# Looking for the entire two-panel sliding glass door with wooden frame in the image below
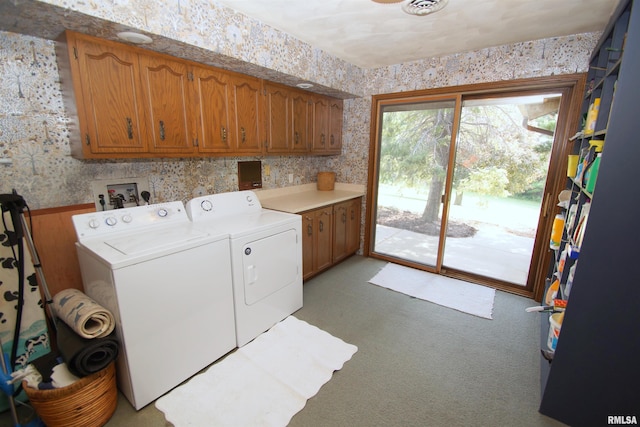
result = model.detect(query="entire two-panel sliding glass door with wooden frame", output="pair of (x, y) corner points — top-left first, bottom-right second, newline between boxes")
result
(369, 85), (566, 296)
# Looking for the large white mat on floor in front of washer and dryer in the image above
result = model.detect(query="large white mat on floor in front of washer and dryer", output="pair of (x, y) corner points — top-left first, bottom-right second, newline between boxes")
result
(156, 316), (358, 427)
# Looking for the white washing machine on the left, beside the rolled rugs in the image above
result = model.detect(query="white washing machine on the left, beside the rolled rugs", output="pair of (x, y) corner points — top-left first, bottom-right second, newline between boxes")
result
(72, 202), (236, 410)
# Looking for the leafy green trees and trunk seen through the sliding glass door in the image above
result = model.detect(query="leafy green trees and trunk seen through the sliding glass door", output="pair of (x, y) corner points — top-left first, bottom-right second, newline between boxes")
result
(379, 102), (556, 221)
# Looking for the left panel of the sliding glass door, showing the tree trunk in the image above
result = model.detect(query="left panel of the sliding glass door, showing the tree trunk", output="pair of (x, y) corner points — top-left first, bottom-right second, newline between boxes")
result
(374, 98), (457, 269)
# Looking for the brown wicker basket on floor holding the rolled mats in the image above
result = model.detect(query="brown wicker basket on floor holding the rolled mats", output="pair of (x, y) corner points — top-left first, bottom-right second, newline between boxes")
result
(22, 362), (118, 427)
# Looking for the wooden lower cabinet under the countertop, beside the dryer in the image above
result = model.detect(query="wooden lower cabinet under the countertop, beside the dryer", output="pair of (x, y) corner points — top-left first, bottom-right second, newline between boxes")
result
(301, 198), (362, 280)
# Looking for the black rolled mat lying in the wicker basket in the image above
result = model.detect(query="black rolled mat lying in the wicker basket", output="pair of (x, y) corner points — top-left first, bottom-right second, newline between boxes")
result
(56, 322), (118, 377)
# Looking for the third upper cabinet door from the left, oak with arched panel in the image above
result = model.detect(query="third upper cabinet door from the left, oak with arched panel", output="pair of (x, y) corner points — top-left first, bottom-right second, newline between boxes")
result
(193, 67), (237, 153)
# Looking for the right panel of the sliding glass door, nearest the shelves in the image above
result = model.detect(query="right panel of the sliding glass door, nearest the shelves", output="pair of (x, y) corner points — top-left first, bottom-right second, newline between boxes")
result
(442, 93), (561, 286)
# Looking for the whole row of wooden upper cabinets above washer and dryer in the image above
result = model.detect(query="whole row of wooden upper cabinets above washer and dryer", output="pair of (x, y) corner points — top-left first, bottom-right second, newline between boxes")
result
(56, 31), (342, 159)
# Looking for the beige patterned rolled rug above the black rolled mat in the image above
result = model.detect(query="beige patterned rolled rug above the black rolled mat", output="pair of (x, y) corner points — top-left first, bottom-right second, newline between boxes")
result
(52, 289), (116, 338)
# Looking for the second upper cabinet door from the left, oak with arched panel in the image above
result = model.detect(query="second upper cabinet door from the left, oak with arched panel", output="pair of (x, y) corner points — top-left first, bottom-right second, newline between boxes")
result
(140, 55), (195, 153)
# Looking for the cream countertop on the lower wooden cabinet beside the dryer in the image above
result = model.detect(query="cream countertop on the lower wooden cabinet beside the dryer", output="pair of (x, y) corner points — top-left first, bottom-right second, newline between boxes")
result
(254, 182), (364, 213)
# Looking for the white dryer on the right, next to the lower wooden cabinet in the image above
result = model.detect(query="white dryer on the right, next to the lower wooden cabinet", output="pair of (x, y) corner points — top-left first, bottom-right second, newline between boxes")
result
(186, 191), (302, 347)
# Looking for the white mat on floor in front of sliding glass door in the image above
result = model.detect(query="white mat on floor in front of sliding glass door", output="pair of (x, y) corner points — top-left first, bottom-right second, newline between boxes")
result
(369, 263), (496, 319)
